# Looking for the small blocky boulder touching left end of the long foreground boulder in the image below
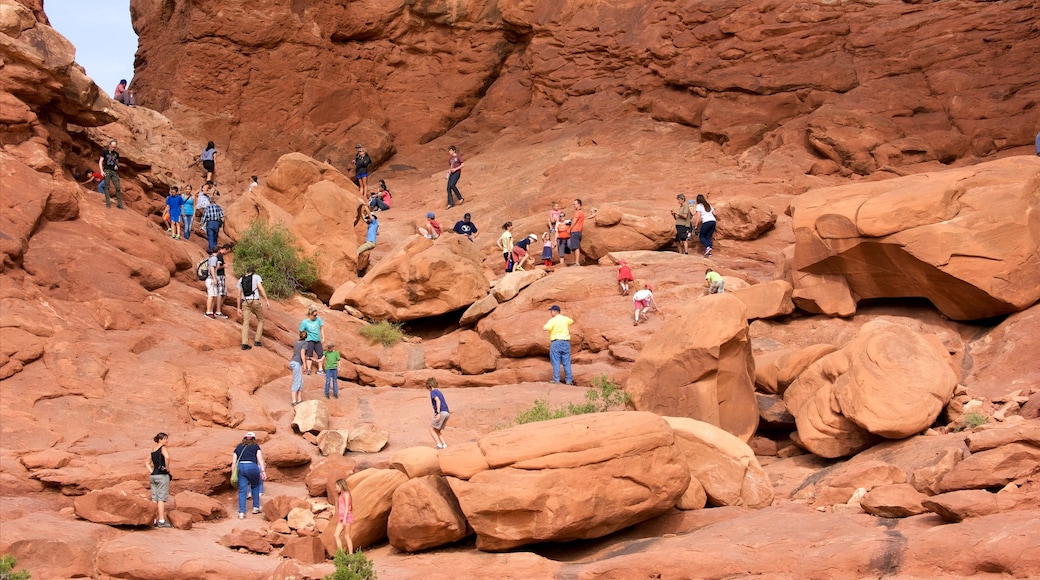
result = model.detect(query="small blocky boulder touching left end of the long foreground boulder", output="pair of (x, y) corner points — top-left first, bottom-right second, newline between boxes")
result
(387, 475), (472, 552)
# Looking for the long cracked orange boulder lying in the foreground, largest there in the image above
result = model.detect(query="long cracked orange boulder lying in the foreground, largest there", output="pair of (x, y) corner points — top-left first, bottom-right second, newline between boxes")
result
(441, 412), (690, 551)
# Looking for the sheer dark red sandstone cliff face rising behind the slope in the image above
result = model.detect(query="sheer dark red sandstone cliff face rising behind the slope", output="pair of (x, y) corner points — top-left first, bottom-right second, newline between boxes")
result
(131, 0), (1040, 175)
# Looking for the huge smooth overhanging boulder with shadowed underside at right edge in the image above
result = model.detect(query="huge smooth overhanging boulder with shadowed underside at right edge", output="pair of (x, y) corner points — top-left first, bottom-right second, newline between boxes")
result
(788, 157), (1040, 320)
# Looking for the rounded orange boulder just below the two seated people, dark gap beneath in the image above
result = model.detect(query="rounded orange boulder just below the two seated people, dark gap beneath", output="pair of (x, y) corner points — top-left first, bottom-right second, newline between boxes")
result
(344, 235), (488, 321)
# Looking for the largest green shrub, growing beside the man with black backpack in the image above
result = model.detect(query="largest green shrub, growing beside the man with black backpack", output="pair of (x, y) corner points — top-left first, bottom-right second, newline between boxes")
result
(233, 219), (318, 298)
